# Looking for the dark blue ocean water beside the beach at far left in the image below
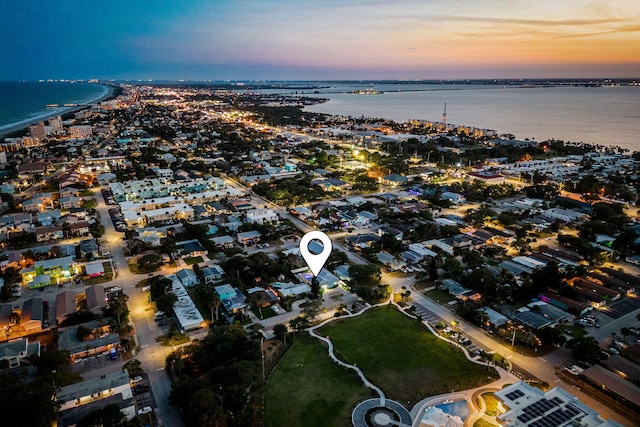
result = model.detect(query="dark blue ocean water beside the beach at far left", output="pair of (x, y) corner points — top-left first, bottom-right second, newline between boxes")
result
(0, 82), (109, 132)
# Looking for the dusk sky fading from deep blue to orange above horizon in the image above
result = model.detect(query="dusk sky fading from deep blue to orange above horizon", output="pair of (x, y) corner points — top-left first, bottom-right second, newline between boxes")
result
(0, 0), (640, 80)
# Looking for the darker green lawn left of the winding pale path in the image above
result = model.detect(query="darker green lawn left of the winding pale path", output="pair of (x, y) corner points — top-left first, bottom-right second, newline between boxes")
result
(265, 336), (372, 427)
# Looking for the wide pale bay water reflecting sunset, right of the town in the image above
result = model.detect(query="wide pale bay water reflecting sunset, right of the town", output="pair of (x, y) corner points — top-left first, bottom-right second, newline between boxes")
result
(305, 83), (640, 152)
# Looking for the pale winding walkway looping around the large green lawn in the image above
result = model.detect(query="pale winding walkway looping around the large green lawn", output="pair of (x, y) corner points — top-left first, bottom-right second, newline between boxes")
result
(307, 294), (519, 427)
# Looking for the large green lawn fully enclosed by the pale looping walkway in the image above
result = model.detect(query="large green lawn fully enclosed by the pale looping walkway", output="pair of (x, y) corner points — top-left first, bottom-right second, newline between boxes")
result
(318, 306), (497, 404)
